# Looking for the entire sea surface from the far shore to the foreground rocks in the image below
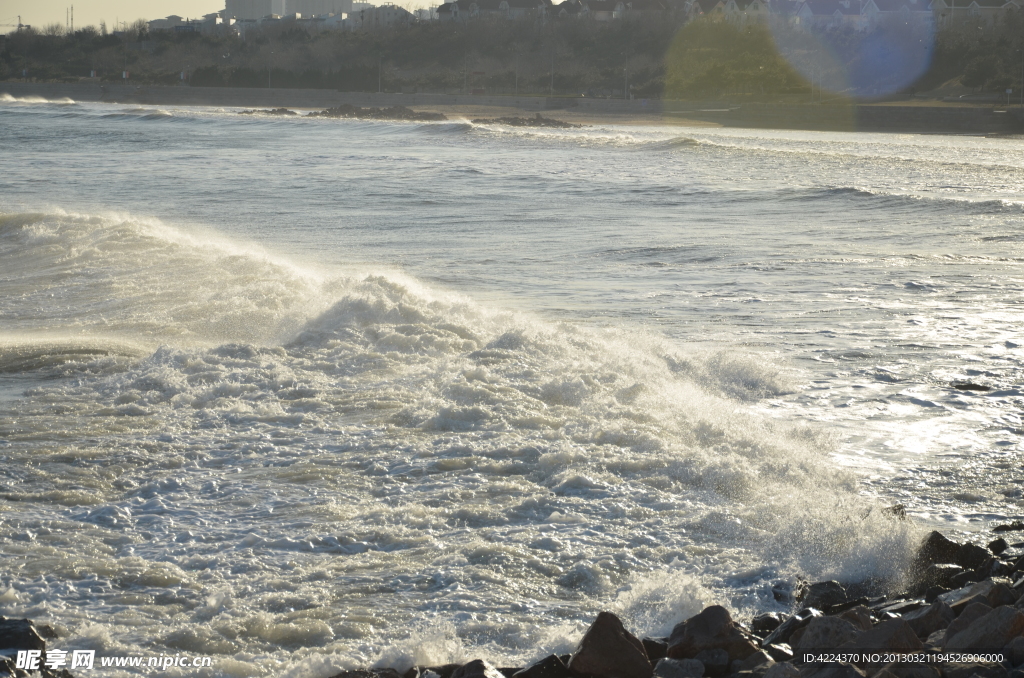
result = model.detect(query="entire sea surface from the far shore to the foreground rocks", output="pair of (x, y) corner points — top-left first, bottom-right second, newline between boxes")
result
(0, 96), (1024, 678)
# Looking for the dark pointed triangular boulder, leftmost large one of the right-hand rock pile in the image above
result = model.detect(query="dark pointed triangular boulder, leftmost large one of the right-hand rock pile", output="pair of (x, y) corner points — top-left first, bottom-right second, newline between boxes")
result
(568, 612), (651, 678)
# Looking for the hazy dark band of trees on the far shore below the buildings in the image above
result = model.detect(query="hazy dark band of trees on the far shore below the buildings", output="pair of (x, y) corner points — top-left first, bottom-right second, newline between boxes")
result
(0, 11), (1024, 100)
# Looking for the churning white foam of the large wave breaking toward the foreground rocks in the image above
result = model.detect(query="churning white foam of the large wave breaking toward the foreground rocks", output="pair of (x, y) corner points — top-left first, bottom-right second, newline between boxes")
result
(0, 212), (929, 675)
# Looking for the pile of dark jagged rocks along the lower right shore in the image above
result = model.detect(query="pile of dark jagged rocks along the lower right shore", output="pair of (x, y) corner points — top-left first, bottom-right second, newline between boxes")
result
(334, 524), (1024, 678)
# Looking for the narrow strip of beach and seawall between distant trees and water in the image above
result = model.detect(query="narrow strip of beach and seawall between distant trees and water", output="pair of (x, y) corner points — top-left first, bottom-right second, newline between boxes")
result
(0, 81), (1024, 135)
